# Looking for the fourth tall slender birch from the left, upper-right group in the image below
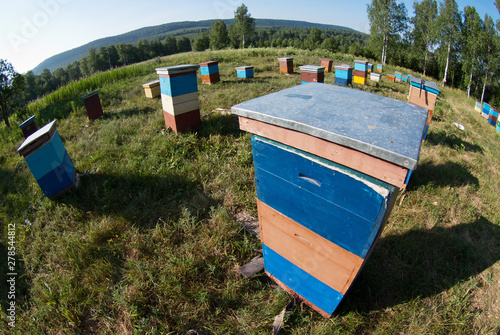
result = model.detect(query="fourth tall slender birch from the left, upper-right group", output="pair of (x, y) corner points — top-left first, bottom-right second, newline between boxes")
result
(462, 6), (484, 97)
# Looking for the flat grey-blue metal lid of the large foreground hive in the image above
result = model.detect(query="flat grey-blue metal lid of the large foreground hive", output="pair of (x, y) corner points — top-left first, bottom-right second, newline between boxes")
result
(231, 83), (427, 169)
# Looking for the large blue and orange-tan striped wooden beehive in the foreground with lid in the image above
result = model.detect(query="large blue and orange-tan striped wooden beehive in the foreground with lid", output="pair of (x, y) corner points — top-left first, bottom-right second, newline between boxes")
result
(231, 83), (427, 317)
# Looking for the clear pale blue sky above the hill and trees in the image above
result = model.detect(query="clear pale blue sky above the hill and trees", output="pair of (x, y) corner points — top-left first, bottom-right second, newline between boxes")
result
(0, 0), (500, 73)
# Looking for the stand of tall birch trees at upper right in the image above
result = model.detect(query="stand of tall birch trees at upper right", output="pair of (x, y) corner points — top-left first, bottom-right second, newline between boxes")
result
(367, 0), (500, 102)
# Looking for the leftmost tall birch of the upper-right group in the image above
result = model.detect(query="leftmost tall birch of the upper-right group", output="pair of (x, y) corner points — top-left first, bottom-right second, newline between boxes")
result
(367, 0), (408, 64)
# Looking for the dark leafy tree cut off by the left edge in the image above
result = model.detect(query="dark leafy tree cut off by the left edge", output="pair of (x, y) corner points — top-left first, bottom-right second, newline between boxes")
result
(0, 59), (24, 127)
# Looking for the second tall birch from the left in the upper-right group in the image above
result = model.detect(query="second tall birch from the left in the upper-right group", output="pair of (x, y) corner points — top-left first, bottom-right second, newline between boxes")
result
(412, 0), (438, 76)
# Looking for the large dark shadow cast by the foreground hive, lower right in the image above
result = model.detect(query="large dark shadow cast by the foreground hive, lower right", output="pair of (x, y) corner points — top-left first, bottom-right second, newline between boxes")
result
(338, 217), (500, 314)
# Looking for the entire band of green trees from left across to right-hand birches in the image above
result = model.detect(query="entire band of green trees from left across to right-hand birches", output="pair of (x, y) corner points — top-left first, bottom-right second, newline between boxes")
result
(0, 0), (500, 124)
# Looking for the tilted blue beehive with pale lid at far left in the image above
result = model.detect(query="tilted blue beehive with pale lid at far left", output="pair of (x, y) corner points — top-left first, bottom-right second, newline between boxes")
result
(17, 120), (76, 199)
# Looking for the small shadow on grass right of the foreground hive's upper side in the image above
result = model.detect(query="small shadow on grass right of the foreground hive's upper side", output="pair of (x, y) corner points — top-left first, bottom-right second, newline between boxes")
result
(408, 162), (479, 191)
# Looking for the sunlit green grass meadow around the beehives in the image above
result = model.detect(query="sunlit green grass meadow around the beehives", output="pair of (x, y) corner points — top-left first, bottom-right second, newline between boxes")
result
(0, 49), (500, 334)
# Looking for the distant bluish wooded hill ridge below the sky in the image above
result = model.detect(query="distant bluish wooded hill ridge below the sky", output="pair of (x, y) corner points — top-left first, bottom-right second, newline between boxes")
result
(32, 19), (360, 74)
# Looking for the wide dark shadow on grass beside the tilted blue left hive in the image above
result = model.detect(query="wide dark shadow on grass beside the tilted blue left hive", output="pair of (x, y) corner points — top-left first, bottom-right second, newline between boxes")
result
(57, 173), (214, 229)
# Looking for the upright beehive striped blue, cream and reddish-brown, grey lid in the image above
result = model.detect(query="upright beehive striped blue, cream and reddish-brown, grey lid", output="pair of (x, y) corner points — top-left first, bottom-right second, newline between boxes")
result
(156, 64), (201, 134)
